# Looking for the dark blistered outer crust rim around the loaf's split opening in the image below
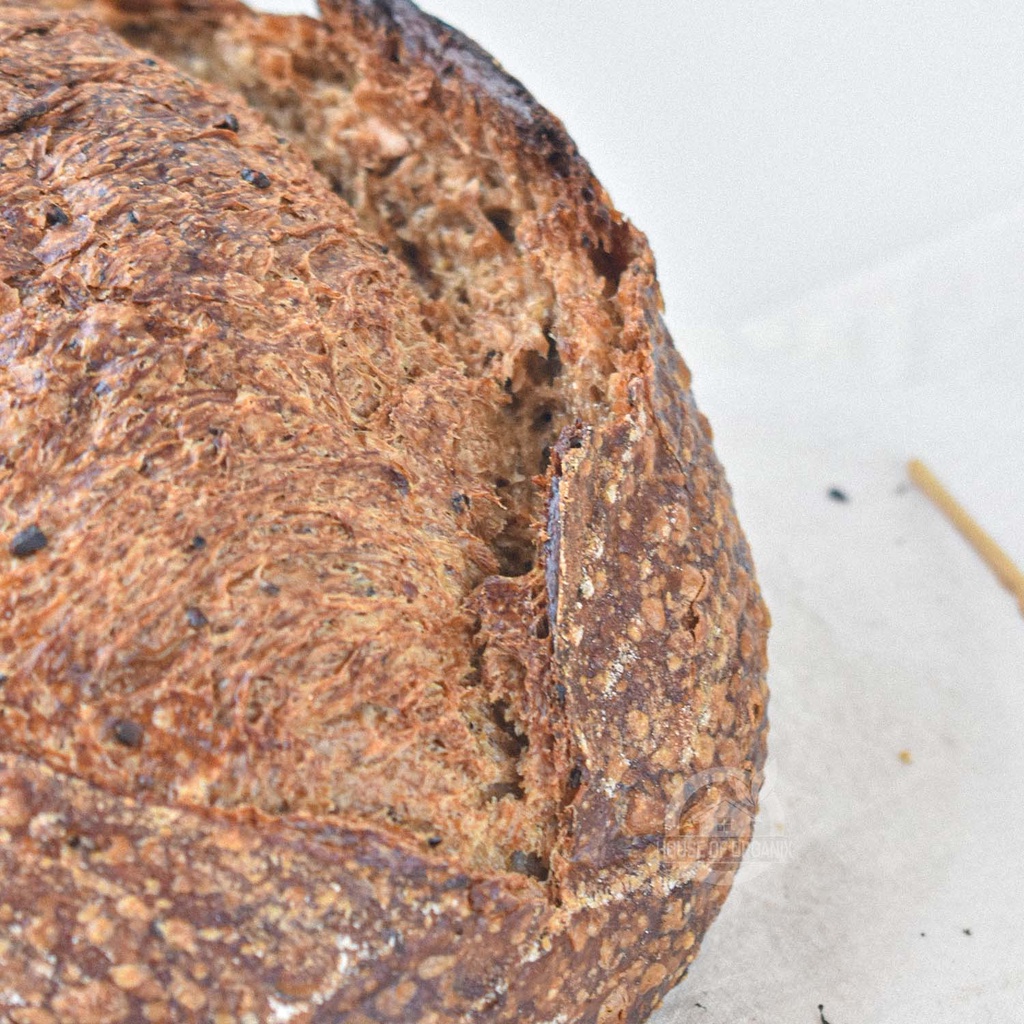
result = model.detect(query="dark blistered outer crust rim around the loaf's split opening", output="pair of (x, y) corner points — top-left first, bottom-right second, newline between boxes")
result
(0, 0), (768, 1024)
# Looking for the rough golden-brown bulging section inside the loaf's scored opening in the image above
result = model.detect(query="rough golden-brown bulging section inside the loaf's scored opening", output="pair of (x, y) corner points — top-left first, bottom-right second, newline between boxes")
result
(0, 2), (552, 880)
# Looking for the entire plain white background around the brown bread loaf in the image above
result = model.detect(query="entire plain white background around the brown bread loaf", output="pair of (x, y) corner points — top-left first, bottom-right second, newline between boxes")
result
(264, 0), (1024, 1024)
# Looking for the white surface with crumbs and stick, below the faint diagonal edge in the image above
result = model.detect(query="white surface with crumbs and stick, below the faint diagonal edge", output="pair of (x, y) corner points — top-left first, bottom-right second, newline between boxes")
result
(658, 212), (1024, 1024)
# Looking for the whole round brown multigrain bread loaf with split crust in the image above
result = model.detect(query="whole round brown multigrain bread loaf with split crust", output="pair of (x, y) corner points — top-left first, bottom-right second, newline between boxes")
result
(0, 0), (768, 1024)
